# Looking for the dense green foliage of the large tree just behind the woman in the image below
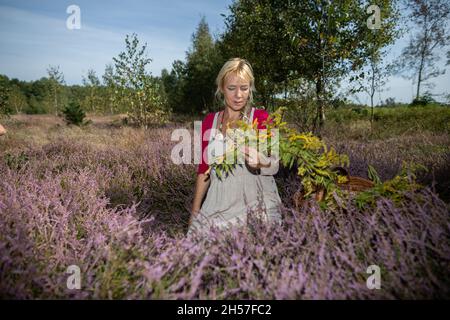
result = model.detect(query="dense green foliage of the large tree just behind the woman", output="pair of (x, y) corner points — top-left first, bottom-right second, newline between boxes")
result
(221, 0), (396, 131)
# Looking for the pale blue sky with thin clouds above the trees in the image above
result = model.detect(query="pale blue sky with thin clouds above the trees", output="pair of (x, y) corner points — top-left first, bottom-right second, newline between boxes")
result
(0, 0), (450, 103)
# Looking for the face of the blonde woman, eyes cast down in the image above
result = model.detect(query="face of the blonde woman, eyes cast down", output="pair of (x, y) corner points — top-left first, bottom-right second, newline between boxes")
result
(222, 73), (250, 111)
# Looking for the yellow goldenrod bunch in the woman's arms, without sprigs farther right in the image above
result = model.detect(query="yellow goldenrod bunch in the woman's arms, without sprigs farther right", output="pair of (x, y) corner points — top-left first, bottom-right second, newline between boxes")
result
(208, 107), (349, 208)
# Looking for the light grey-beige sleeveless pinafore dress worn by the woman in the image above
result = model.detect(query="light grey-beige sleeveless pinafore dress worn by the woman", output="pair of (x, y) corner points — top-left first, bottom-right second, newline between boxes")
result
(188, 108), (281, 234)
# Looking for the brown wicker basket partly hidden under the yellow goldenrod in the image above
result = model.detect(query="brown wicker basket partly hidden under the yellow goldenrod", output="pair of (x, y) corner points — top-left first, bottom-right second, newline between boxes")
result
(292, 167), (374, 210)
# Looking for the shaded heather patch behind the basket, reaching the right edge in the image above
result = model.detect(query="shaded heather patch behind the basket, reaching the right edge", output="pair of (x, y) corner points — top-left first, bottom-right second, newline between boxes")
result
(324, 133), (450, 202)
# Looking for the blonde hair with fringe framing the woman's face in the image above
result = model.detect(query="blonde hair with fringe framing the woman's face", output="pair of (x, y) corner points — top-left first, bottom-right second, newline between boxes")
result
(215, 58), (256, 117)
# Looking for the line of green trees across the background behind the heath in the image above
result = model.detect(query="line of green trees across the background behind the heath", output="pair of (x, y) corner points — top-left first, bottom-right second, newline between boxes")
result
(0, 0), (450, 130)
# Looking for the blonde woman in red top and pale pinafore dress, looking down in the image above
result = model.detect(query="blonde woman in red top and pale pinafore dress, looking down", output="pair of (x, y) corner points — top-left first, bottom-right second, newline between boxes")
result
(188, 58), (281, 233)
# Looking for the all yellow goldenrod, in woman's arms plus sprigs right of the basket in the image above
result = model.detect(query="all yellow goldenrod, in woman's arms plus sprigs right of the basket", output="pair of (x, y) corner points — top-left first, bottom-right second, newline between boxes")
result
(206, 107), (420, 208)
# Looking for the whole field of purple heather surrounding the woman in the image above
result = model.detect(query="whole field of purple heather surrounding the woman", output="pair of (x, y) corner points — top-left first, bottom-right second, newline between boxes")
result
(0, 115), (450, 299)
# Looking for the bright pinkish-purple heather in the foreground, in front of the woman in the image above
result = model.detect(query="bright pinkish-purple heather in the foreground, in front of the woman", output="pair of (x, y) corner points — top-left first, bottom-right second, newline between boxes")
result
(0, 165), (450, 299)
